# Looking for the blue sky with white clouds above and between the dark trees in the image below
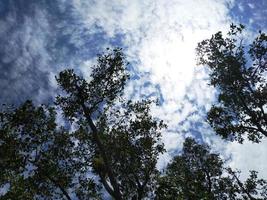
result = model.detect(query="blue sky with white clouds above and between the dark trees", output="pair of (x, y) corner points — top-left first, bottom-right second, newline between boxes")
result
(0, 0), (267, 178)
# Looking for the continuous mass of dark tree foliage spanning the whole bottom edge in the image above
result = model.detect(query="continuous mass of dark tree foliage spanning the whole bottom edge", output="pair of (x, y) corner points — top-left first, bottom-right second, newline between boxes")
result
(0, 45), (267, 200)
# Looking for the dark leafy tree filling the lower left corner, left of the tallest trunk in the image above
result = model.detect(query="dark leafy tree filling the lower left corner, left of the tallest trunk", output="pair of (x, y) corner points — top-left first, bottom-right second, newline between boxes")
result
(0, 101), (100, 199)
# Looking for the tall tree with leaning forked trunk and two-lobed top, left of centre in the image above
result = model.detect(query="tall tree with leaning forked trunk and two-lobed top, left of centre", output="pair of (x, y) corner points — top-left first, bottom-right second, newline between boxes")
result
(57, 49), (165, 200)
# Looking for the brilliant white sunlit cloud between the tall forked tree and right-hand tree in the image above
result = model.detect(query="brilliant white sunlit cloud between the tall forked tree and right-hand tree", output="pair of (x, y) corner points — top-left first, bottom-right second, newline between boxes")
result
(69, 0), (266, 178)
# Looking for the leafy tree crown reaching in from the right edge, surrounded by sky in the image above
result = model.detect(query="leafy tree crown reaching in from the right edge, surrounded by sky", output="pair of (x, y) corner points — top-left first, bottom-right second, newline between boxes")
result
(196, 24), (267, 143)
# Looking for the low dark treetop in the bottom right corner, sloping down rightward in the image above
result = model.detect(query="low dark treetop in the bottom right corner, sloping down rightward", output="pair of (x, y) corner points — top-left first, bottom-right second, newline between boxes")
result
(156, 138), (267, 200)
